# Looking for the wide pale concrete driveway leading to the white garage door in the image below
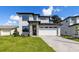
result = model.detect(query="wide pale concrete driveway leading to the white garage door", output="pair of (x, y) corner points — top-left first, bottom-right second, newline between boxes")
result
(41, 36), (79, 52)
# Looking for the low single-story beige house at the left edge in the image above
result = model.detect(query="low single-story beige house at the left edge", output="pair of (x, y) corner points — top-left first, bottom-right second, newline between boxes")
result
(0, 25), (16, 36)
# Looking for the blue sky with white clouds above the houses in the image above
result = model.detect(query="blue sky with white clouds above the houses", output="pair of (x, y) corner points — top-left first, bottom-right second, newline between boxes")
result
(0, 6), (79, 25)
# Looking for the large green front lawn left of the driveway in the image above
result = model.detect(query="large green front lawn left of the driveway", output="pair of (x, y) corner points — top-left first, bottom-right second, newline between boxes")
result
(0, 36), (54, 52)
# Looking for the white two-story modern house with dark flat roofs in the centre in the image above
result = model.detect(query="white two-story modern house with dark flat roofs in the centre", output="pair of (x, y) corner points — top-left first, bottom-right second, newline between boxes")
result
(17, 12), (60, 36)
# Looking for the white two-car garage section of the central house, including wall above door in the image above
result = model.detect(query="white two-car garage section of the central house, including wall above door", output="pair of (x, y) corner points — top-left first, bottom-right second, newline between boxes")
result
(39, 25), (60, 36)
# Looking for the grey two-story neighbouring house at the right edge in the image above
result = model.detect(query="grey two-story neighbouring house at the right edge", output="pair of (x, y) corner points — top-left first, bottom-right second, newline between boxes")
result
(61, 16), (79, 37)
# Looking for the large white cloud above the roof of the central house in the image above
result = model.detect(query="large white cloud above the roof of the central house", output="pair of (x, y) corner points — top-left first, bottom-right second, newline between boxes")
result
(42, 6), (61, 16)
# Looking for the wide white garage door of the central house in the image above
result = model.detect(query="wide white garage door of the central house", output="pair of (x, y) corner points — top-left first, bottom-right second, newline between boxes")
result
(39, 28), (57, 36)
